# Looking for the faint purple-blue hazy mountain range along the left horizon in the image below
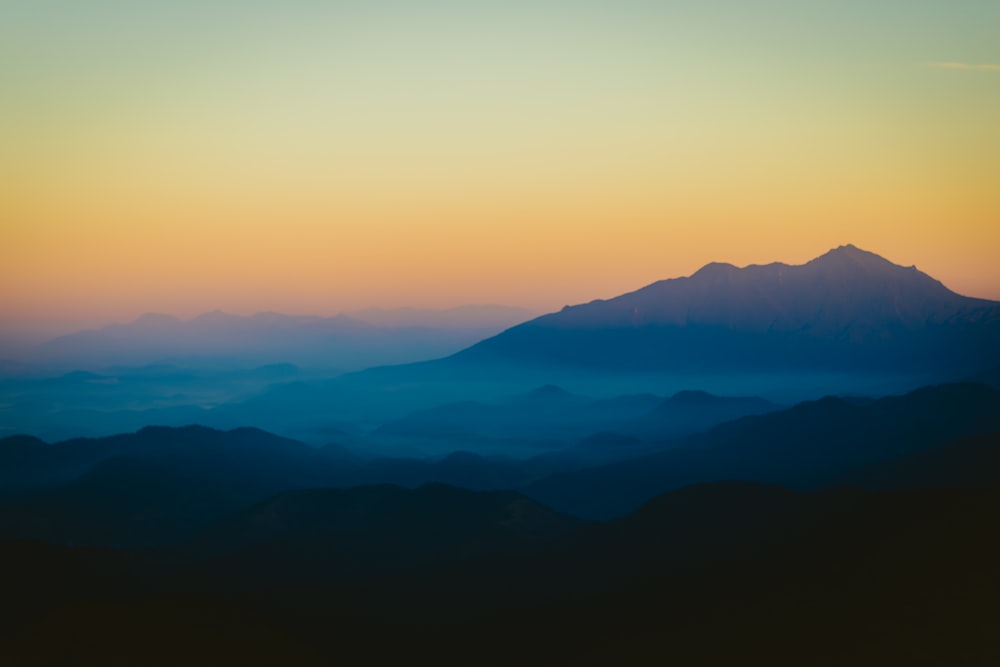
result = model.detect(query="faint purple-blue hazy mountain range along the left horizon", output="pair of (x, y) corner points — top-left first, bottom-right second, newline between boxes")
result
(24, 306), (531, 371)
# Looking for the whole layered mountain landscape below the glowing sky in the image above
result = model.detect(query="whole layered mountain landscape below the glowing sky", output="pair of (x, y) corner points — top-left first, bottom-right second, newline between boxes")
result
(0, 246), (1000, 667)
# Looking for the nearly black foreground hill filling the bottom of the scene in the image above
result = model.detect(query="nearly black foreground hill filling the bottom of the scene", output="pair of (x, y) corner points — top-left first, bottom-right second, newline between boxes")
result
(0, 483), (1000, 666)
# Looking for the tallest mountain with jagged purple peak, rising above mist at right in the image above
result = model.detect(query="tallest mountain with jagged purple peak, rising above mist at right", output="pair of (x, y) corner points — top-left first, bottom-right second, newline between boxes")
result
(449, 245), (1000, 373)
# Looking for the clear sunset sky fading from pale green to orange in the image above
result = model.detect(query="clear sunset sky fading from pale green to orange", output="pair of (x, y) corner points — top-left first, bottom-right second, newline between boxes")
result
(0, 0), (1000, 333)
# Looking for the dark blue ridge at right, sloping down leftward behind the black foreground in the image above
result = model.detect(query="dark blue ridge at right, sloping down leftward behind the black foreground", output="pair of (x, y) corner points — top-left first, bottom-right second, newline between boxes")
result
(524, 384), (1000, 518)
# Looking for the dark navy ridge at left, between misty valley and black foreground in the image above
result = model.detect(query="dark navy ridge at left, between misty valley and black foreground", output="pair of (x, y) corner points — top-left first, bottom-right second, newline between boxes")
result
(0, 426), (574, 547)
